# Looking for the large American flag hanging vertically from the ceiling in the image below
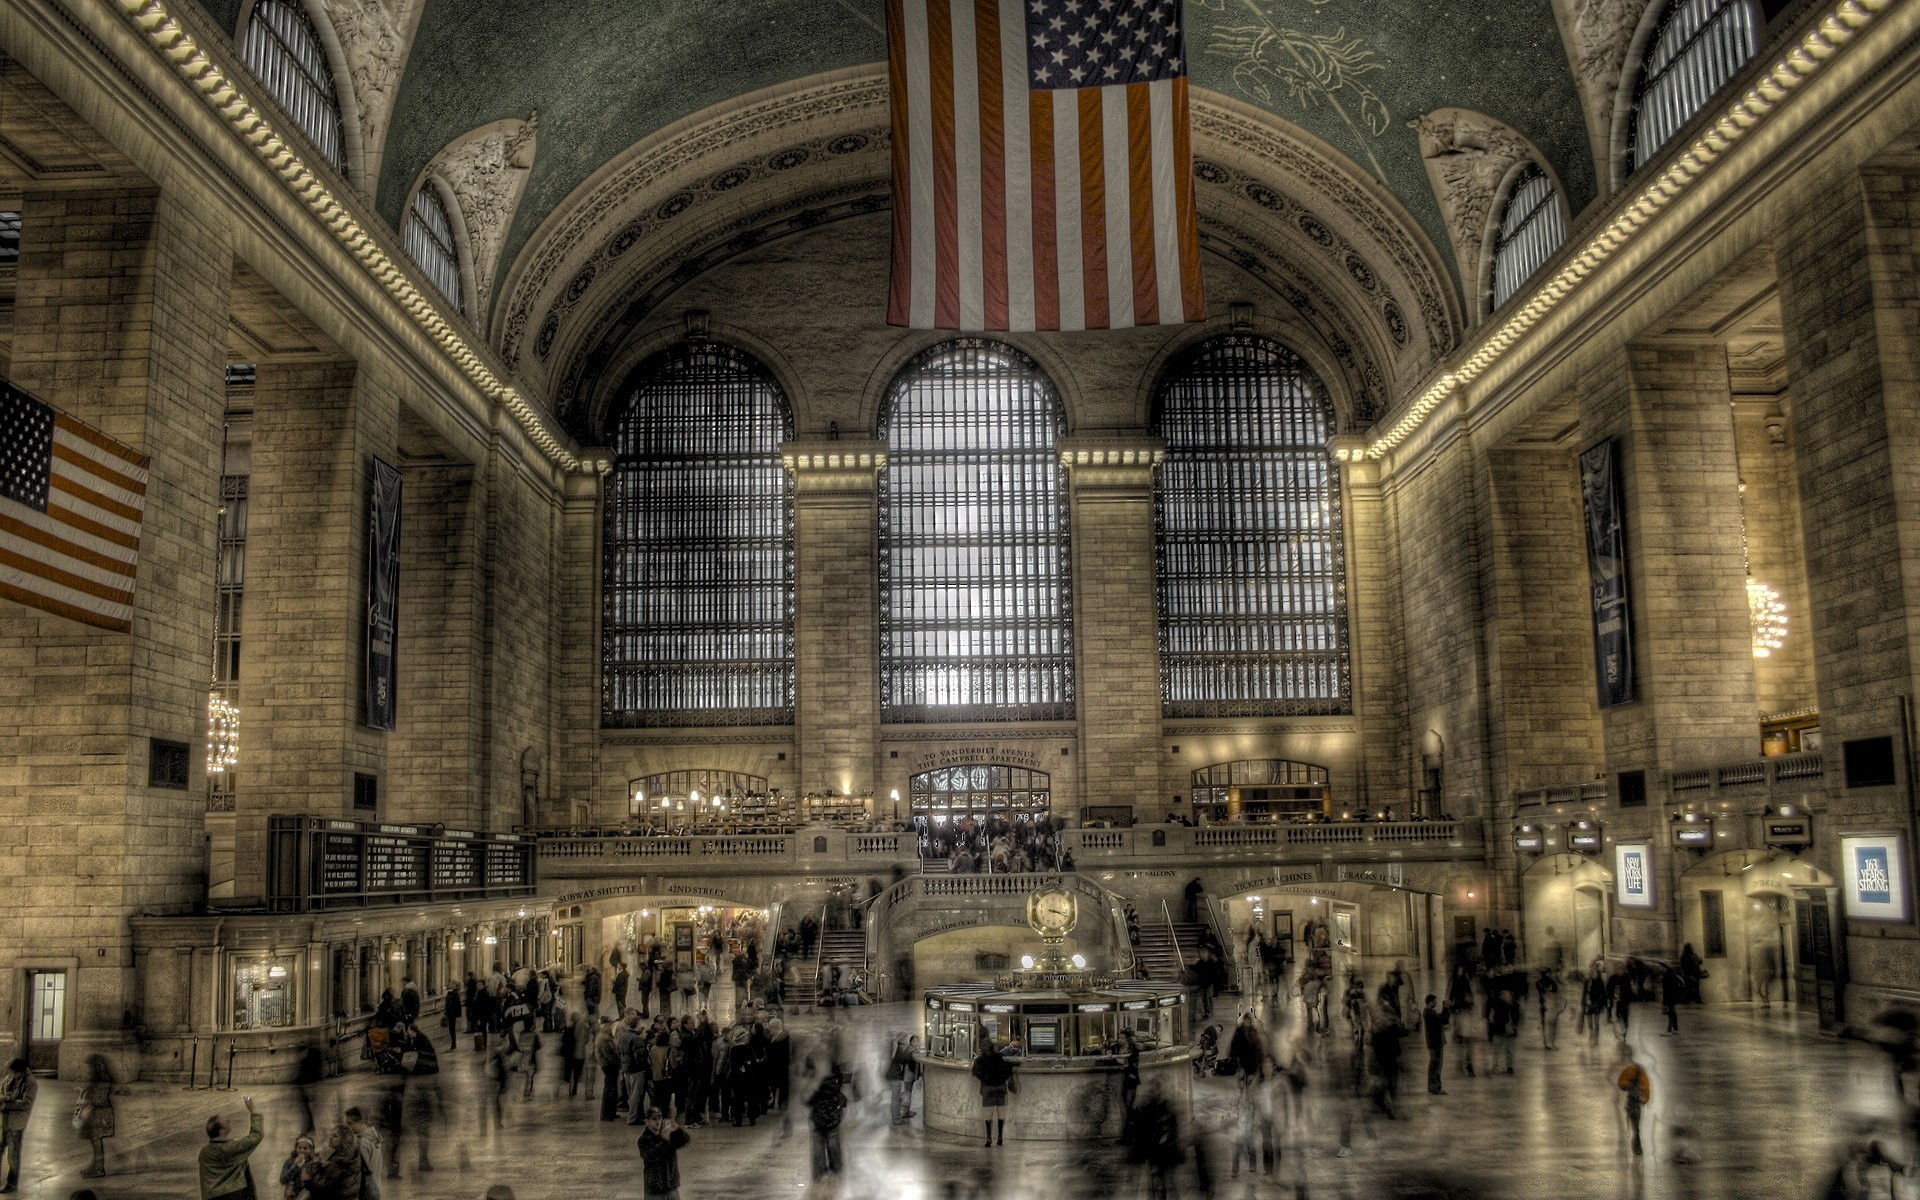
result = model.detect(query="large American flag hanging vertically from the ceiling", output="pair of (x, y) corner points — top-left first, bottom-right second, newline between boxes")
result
(887, 0), (1206, 330)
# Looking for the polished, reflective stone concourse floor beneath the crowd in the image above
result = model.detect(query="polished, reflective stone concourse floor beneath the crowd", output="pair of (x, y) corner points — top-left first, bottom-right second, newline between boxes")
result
(7, 975), (1920, 1200)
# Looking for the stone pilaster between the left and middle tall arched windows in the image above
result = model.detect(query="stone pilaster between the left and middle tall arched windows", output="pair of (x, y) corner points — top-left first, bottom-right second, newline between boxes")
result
(780, 442), (887, 795)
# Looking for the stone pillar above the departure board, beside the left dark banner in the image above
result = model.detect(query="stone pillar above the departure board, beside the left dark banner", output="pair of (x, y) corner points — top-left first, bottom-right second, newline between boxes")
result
(234, 361), (407, 897)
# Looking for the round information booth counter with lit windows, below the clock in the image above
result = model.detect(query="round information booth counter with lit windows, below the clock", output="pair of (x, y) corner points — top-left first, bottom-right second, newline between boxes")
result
(920, 972), (1192, 1140)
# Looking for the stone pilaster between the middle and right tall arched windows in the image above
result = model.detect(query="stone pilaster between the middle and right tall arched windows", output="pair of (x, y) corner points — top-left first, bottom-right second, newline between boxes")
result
(1054, 438), (1165, 820)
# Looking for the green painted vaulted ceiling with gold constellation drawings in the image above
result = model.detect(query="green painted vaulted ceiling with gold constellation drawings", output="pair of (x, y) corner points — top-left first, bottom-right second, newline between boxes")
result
(202, 0), (1594, 309)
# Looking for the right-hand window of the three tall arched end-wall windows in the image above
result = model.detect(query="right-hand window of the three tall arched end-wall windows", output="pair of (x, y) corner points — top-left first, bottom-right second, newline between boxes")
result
(1154, 334), (1352, 716)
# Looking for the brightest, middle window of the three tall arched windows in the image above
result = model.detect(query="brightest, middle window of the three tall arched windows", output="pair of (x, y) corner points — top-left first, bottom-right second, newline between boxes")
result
(879, 338), (1073, 722)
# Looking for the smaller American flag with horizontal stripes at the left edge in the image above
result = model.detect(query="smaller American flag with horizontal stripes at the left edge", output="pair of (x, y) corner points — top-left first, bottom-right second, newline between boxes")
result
(0, 380), (148, 632)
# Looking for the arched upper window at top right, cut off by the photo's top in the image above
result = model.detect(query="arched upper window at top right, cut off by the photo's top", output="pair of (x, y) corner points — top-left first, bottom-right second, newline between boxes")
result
(1628, 0), (1761, 171)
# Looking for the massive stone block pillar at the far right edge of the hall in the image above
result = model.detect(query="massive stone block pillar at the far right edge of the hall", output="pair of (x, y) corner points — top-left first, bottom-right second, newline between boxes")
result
(1774, 167), (1920, 1014)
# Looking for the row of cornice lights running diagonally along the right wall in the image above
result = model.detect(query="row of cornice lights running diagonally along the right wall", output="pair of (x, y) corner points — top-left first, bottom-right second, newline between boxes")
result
(1334, 0), (1897, 461)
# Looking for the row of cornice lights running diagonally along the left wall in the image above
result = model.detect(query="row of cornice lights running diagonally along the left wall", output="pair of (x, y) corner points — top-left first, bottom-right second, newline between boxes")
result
(117, 0), (576, 470)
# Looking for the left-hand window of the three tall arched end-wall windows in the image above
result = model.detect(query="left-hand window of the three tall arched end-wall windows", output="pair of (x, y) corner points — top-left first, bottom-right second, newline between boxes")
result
(601, 344), (793, 726)
